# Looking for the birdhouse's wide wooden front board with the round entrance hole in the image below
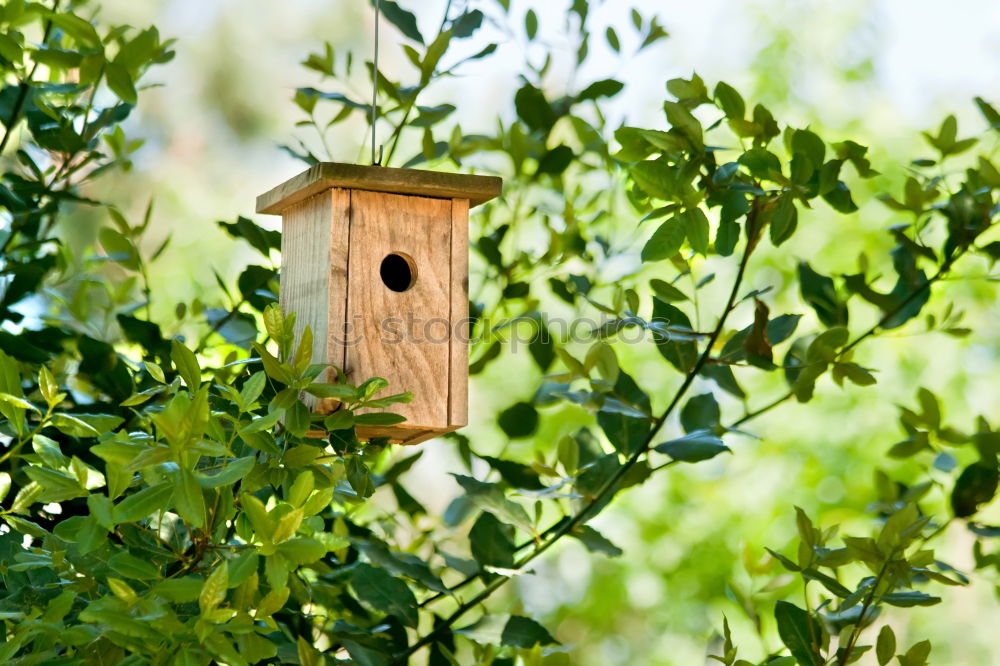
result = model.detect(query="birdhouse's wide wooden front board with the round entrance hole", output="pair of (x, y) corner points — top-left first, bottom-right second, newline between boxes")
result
(345, 191), (452, 429)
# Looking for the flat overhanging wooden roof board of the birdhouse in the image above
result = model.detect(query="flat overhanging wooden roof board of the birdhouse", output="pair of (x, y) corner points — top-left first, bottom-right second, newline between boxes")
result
(257, 162), (503, 215)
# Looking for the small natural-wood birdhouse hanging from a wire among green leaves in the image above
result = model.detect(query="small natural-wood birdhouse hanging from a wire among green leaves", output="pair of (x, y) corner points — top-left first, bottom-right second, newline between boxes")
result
(257, 163), (501, 444)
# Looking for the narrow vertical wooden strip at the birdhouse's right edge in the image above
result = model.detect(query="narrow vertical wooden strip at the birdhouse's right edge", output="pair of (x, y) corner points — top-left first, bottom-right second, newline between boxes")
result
(448, 199), (469, 428)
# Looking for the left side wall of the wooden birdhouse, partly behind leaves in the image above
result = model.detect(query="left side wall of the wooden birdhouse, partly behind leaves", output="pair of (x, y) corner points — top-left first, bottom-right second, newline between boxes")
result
(279, 189), (351, 411)
